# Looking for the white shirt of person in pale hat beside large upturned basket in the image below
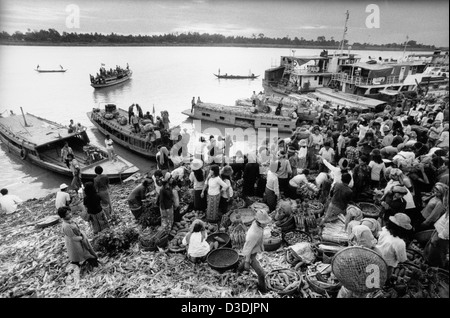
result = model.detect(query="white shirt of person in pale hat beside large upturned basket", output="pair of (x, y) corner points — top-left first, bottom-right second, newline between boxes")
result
(376, 227), (408, 267)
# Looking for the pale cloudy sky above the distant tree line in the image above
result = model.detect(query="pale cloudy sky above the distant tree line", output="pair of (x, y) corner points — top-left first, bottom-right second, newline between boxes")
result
(0, 0), (449, 47)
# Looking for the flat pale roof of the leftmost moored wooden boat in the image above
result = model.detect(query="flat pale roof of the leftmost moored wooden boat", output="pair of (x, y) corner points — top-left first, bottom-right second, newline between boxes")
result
(0, 113), (77, 147)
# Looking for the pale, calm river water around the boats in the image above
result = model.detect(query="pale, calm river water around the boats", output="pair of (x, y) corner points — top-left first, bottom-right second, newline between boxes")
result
(0, 46), (430, 199)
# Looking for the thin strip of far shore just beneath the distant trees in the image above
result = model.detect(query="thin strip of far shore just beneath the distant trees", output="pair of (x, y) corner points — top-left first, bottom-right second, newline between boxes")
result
(0, 41), (440, 52)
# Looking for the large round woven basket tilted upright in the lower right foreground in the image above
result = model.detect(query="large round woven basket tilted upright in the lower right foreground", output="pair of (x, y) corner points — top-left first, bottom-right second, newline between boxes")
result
(331, 246), (388, 293)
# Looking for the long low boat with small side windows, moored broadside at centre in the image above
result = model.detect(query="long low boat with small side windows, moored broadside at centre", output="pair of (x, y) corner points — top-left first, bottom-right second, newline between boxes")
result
(182, 103), (317, 133)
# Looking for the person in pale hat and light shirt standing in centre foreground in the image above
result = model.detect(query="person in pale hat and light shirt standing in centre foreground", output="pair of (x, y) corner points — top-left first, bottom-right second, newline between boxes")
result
(237, 210), (272, 293)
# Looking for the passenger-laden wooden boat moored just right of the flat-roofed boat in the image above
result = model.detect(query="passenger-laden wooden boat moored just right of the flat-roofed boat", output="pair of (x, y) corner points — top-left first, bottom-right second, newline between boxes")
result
(87, 108), (178, 159)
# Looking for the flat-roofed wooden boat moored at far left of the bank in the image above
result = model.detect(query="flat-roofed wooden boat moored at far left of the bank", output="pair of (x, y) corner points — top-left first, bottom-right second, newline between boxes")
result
(0, 113), (139, 181)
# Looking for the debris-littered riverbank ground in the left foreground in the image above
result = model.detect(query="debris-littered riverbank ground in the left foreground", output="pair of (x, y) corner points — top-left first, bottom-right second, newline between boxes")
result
(0, 174), (284, 298)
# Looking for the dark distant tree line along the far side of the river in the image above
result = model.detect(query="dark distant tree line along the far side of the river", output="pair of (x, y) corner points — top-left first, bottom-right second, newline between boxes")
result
(0, 29), (436, 49)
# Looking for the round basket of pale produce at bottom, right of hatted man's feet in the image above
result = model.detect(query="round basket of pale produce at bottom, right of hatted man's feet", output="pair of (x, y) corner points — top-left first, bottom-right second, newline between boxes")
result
(266, 268), (302, 296)
